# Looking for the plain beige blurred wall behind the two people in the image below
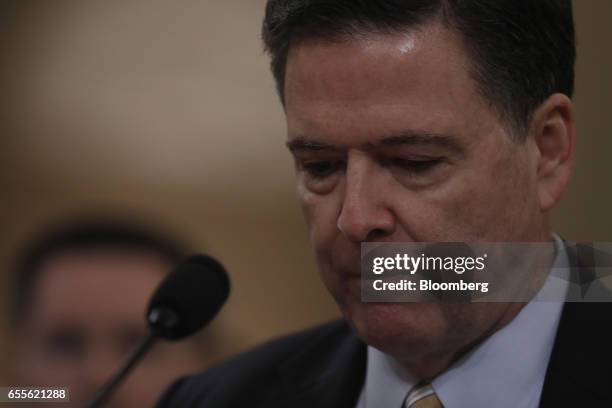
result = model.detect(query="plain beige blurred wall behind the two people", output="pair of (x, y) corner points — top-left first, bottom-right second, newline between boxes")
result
(0, 0), (612, 376)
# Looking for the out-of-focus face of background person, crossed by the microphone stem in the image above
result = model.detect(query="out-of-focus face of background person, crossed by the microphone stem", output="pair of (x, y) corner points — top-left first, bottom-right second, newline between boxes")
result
(15, 251), (199, 407)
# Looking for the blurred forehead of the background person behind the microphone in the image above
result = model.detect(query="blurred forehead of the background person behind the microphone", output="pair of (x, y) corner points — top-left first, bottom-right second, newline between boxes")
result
(30, 250), (168, 321)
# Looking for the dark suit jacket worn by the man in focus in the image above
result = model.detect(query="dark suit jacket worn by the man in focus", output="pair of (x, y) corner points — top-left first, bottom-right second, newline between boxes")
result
(158, 244), (612, 408)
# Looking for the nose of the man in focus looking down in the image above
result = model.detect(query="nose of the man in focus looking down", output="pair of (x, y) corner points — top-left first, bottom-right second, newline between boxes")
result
(337, 152), (396, 242)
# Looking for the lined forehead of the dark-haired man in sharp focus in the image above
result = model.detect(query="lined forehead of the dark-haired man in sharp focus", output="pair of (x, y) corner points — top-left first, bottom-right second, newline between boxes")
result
(285, 22), (490, 145)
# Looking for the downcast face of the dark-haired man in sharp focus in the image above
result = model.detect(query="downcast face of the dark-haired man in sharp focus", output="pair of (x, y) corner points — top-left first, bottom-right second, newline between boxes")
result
(285, 23), (548, 364)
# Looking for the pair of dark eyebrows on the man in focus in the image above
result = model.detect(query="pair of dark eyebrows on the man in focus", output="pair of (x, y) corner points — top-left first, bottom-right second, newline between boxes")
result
(287, 131), (463, 152)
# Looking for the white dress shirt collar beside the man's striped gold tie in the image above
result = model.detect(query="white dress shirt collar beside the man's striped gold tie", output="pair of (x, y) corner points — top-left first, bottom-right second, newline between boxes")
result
(356, 235), (569, 408)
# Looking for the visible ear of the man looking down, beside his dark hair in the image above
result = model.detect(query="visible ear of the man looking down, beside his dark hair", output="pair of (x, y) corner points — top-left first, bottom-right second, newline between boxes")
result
(532, 93), (576, 211)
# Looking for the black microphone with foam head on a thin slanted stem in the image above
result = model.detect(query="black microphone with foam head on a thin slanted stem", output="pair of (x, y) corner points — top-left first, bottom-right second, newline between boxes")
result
(87, 255), (230, 408)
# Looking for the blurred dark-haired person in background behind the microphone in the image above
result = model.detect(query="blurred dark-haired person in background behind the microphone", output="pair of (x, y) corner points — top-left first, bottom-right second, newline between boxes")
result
(10, 219), (214, 407)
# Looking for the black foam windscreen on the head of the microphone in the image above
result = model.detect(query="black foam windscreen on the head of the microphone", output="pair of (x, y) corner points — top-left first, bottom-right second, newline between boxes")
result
(147, 255), (230, 340)
